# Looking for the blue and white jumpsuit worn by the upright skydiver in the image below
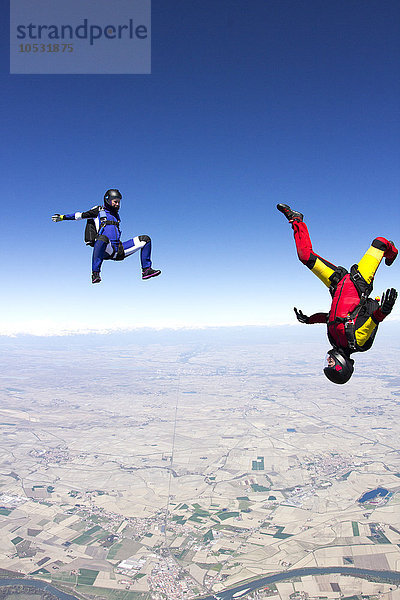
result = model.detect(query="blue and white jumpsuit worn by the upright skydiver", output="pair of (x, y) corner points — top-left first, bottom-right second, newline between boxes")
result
(63, 206), (151, 273)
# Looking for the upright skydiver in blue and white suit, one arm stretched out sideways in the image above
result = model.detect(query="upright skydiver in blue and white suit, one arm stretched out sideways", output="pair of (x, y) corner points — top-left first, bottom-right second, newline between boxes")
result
(51, 189), (161, 283)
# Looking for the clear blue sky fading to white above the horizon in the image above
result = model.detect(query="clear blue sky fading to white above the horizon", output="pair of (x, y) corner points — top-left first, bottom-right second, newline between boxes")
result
(0, 0), (400, 332)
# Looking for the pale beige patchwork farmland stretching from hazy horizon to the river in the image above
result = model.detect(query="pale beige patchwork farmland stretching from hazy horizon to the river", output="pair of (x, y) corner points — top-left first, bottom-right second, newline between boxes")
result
(0, 333), (400, 600)
